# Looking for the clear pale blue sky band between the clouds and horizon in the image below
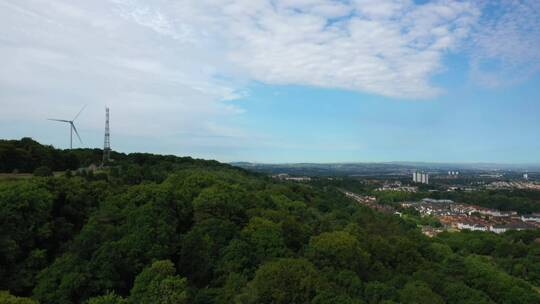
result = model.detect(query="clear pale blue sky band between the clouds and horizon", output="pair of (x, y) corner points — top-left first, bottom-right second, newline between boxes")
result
(232, 73), (540, 163)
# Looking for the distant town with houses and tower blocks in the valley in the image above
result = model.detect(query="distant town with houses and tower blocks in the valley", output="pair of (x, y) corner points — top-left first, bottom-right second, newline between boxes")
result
(241, 163), (540, 236)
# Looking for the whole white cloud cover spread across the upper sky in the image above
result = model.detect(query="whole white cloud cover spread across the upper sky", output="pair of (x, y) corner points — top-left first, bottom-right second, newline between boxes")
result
(0, 0), (540, 157)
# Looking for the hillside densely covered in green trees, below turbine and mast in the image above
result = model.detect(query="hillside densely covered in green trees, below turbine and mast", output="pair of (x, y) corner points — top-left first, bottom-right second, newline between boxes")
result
(0, 139), (540, 304)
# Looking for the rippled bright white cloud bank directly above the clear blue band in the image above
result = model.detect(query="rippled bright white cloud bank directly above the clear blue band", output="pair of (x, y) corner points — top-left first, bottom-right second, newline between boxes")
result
(204, 0), (476, 98)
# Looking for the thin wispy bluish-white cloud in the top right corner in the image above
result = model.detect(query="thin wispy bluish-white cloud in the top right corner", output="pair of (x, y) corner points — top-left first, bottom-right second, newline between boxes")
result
(469, 0), (540, 86)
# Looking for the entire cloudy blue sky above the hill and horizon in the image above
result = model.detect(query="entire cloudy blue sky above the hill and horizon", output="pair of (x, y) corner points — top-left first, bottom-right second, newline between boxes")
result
(0, 0), (540, 164)
